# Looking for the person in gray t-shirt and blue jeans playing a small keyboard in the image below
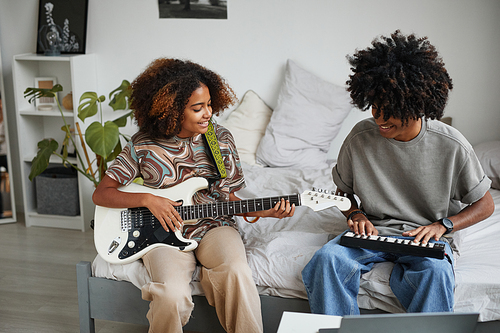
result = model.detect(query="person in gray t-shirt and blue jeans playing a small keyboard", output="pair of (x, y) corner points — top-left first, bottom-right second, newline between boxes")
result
(302, 31), (494, 316)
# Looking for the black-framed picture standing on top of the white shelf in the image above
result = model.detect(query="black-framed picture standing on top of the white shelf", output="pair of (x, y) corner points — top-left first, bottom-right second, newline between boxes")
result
(36, 0), (89, 54)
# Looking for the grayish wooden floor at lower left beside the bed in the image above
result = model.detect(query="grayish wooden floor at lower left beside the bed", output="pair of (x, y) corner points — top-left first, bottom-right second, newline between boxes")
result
(0, 215), (148, 333)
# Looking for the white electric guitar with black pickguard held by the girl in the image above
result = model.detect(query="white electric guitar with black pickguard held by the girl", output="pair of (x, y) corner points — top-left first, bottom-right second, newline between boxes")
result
(94, 177), (351, 264)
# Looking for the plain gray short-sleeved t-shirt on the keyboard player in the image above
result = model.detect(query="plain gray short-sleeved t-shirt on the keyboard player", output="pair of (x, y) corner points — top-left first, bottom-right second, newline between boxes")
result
(332, 118), (491, 235)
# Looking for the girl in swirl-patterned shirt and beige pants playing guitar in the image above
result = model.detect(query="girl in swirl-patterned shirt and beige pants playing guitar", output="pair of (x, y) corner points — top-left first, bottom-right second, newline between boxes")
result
(93, 59), (295, 333)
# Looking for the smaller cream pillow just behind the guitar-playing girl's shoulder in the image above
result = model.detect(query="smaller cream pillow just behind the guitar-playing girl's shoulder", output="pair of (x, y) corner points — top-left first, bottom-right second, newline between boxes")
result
(220, 90), (272, 165)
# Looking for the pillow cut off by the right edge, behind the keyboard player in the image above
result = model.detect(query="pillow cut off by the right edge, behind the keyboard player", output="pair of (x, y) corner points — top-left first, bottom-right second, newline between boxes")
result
(474, 141), (500, 190)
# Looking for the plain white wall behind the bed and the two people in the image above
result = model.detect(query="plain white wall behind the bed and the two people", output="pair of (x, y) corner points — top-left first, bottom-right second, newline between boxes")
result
(0, 0), (500, 213)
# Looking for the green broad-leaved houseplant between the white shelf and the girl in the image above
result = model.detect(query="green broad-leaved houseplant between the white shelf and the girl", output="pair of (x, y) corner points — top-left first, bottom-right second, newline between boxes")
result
(24, 80), (133, 186)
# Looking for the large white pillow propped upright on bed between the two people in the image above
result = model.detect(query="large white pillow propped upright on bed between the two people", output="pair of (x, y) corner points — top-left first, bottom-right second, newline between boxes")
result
(257, 60), (352, 168)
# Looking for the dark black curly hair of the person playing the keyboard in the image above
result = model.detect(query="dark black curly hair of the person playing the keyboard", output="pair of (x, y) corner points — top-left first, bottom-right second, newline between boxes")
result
(347, 30), (453, 124)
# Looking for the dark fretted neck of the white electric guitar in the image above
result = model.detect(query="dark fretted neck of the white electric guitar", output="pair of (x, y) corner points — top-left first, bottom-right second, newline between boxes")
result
(175, 194), (300, 221)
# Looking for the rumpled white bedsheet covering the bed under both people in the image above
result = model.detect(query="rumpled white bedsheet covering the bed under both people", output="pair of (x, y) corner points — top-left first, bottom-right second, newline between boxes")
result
(93, 164), (500, 321)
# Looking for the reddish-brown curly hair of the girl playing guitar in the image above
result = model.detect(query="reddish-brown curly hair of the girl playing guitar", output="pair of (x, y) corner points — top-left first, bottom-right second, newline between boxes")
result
(130, 58), (237, 138)
